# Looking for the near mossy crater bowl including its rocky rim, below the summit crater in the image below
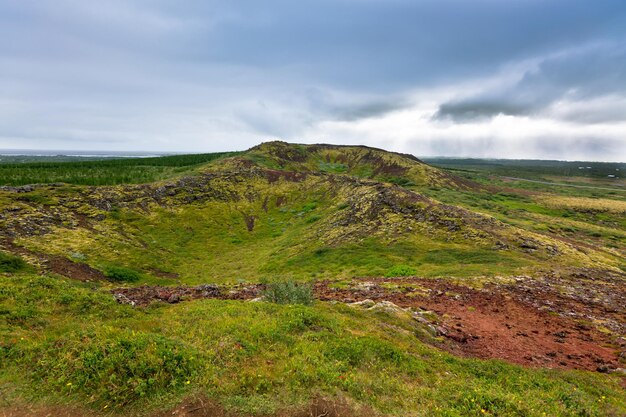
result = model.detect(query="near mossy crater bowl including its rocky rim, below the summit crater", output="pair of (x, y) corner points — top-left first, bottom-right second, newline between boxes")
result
(6, 170), (617, 284)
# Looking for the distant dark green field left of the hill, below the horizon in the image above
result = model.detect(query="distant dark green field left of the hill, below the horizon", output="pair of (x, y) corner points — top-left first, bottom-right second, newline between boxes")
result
(0, 152), (237, 185)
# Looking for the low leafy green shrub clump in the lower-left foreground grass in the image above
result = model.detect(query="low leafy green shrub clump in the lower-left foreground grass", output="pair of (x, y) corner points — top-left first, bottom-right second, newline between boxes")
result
(10, 329), (200, 407)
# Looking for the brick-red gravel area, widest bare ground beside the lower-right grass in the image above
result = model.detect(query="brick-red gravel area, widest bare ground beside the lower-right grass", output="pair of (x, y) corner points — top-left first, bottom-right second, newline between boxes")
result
(412, 284), (616, 370)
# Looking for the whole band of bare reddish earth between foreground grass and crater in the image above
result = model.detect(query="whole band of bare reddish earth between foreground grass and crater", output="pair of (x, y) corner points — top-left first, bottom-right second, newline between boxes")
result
(112, 276), (626, 372)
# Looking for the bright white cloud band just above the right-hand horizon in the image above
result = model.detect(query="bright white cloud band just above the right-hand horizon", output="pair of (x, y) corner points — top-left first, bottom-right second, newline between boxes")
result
(304, 98), (626, 162)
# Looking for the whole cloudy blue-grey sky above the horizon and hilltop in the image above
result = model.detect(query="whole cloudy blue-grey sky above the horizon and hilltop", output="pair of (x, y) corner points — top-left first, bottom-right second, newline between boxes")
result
(0, 0), (626, 162)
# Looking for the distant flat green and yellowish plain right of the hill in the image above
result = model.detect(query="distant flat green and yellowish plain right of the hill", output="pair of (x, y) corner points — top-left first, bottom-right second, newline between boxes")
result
(419, 158), (626, 264)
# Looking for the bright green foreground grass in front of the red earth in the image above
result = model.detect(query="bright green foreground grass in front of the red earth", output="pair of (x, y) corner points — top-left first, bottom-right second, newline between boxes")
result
(0, 275), (626, 416)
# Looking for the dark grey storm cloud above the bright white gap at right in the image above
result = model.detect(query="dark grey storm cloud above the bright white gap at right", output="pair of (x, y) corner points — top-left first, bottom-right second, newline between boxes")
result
(435, 42), (626, 123)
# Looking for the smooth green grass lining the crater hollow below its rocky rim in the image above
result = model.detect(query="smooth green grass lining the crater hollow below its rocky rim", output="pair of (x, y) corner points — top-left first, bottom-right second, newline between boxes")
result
(19, 196), (538, 284)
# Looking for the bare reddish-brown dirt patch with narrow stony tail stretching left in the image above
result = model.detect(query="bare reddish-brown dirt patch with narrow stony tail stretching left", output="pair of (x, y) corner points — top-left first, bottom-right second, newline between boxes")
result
(317, 278), (619, 371)
